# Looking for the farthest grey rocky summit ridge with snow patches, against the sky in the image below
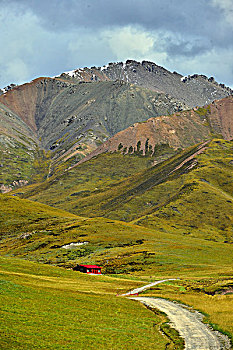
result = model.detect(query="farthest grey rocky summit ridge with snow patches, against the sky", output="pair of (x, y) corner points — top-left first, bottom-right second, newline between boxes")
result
(56, 60), (233, 108)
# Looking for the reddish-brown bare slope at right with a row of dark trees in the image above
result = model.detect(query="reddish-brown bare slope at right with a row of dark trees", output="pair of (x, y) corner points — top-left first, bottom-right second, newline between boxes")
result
(79, 96), (233, 164)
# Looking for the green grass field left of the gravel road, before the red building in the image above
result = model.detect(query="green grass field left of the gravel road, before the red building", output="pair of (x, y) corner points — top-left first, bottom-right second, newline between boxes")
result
(0, 258), (173, 350)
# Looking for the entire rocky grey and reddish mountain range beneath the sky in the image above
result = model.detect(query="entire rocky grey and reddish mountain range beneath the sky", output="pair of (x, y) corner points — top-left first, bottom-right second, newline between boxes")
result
(0, 60), (232, 192)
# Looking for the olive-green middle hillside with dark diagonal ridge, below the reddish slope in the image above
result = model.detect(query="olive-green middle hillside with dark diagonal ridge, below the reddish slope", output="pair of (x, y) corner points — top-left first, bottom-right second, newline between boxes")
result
(14, 140), (233, 242)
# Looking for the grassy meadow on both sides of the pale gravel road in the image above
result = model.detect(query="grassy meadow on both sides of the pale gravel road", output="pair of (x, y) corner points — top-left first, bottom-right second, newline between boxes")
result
(0, 257), (233, 350)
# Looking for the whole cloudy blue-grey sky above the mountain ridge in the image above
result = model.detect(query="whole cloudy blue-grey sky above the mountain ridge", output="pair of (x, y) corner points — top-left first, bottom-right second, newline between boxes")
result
(0, 0), (233, 88)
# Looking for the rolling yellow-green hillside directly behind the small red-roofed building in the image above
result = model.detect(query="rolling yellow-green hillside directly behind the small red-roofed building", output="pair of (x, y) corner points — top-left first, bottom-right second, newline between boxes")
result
(0, 191), (233, 276)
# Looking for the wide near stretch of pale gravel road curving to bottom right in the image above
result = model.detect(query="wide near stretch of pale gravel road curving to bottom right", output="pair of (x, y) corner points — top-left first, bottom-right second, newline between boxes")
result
(130, 297), (231, 350)
